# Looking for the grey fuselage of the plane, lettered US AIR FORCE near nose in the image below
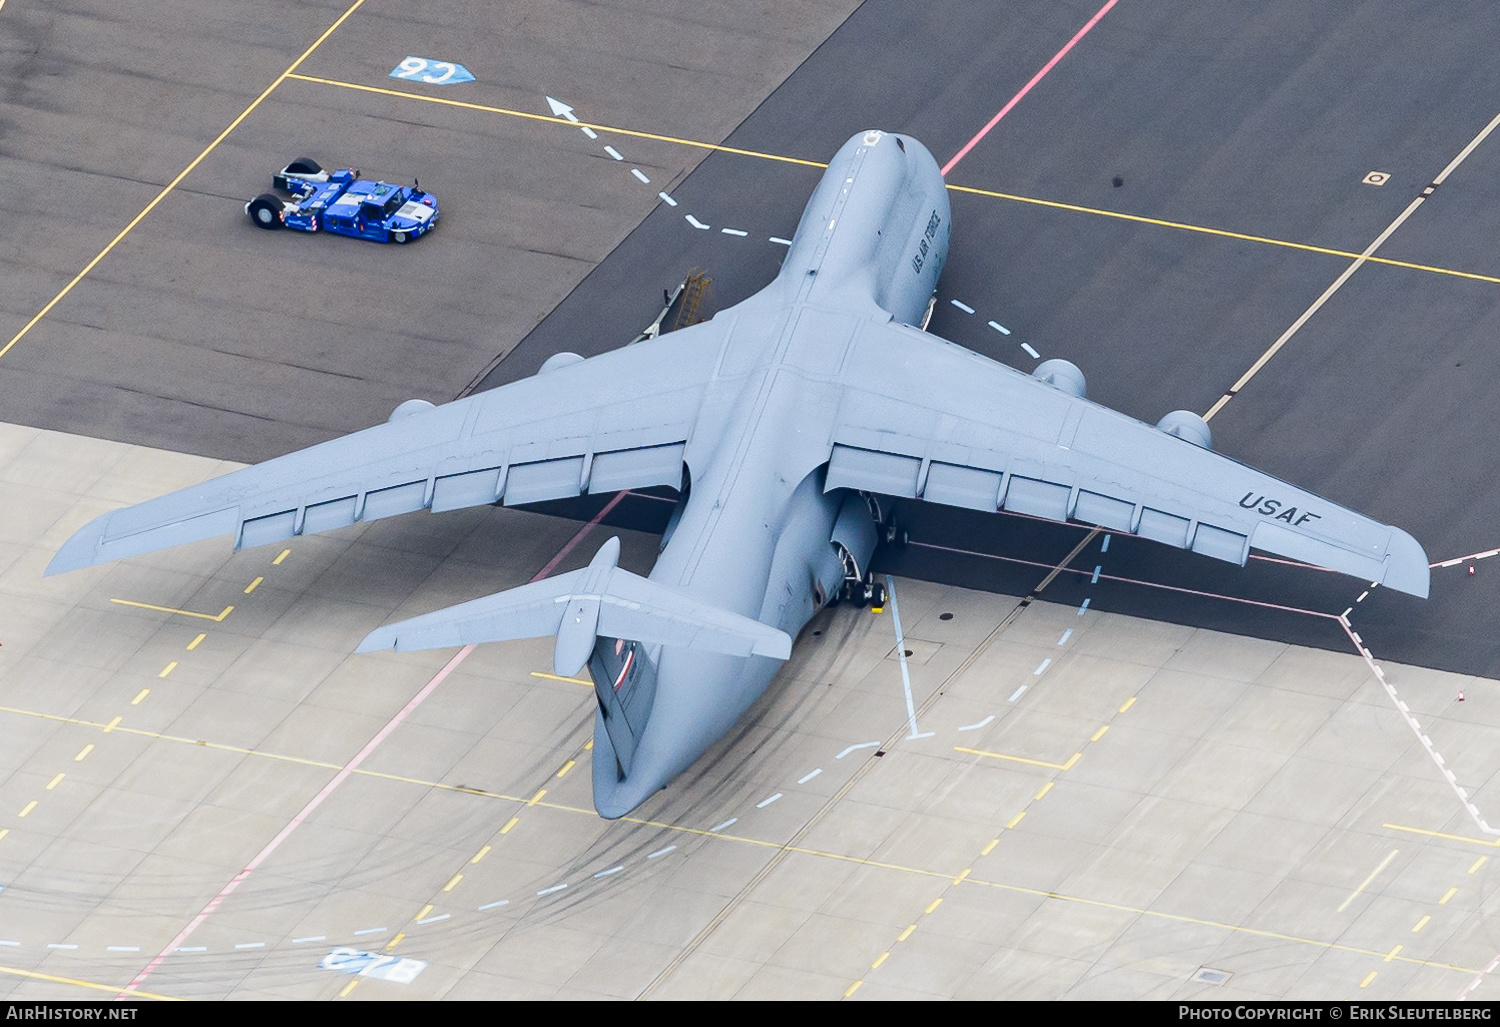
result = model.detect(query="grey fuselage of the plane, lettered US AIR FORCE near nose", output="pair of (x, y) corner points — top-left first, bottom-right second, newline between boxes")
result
(591, 132), (950, 817)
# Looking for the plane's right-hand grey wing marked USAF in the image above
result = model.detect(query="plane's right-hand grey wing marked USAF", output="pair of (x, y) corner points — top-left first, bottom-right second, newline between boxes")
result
(828, 322), (1430, 597)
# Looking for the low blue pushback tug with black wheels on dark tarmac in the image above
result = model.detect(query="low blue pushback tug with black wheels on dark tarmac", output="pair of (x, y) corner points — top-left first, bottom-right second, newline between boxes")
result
(245, 157), (438, 243)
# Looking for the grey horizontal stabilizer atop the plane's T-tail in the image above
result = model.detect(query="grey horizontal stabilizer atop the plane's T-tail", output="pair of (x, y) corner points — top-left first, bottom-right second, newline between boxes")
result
(357, 538), (792, 676)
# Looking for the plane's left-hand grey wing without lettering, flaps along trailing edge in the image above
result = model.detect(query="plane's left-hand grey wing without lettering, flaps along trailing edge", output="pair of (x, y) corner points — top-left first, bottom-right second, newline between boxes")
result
(47, 322), (725, 574)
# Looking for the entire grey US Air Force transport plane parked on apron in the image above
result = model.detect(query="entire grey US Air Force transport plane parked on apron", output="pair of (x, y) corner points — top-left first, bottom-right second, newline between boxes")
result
(47, 132), (1428, 817)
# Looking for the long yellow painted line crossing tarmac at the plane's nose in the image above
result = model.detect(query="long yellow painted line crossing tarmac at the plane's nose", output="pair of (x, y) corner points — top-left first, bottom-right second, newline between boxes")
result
(287, 75), (1500, 285)
